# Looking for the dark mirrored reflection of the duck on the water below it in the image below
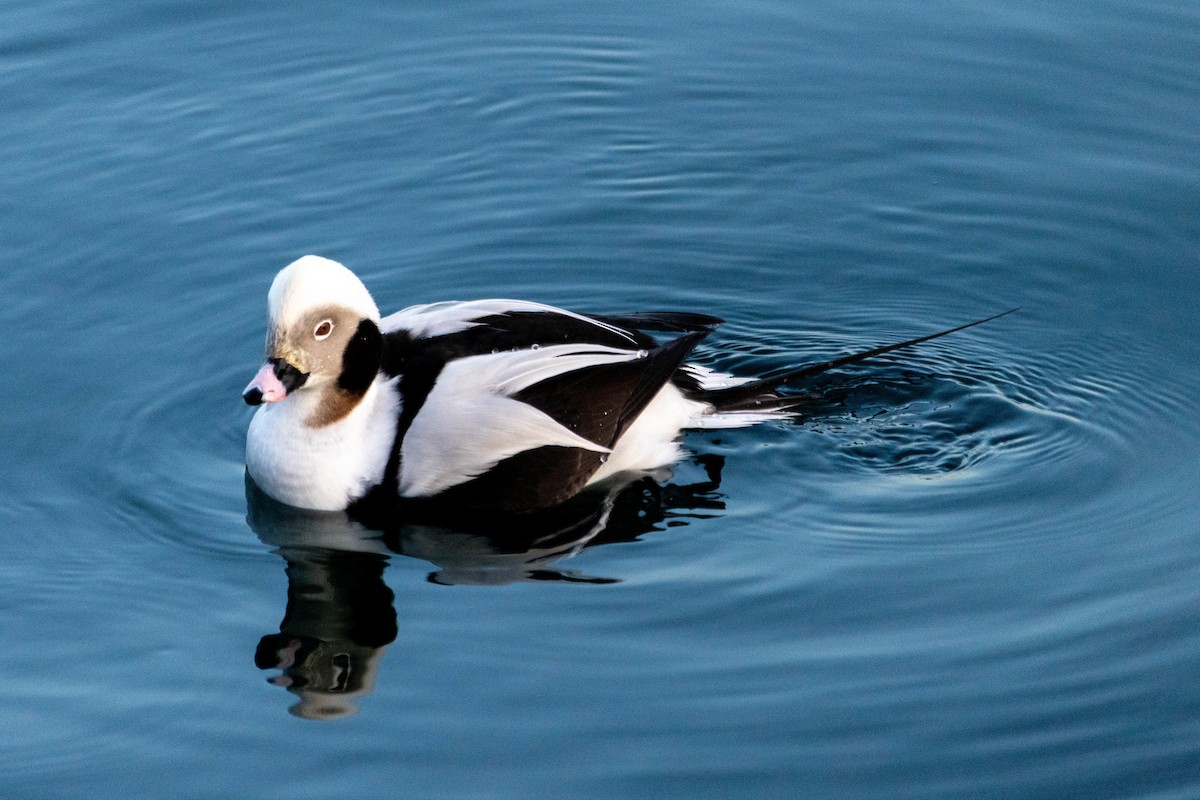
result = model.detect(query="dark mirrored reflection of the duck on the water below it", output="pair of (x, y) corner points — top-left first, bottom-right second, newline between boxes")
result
(246, 455), (725, 720)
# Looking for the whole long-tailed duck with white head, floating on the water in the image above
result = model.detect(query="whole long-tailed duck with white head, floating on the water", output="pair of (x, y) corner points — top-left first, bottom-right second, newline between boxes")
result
(242, 255), (1009, 513)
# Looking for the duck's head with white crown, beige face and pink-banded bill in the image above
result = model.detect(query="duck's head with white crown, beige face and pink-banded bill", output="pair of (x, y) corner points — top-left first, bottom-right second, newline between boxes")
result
(242, 255), (383, 422)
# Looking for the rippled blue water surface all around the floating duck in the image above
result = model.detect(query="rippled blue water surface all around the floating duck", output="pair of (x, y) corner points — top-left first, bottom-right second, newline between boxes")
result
(0, 0), (1200, 799)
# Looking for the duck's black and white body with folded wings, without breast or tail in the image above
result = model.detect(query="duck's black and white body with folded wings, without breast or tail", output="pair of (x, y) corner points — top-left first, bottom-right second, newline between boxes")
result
(357, 300), (719, 511)
